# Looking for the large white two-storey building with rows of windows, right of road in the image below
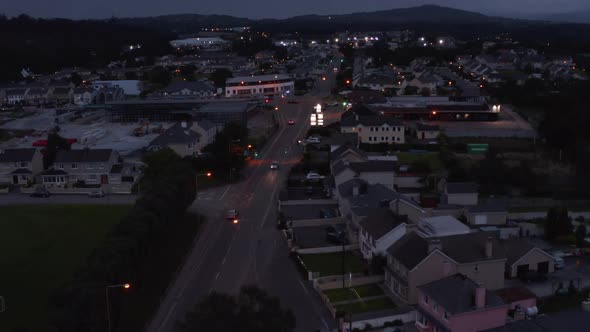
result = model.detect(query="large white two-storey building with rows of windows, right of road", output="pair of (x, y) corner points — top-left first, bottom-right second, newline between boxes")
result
(340, 113), (406, 144)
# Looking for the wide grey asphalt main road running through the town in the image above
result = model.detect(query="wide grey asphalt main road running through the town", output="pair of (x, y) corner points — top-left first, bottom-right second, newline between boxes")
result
(147, 69), (336, 332)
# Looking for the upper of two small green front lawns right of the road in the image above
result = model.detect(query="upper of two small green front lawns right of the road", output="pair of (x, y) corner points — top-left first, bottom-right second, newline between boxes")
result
(300, 252), (364, 276)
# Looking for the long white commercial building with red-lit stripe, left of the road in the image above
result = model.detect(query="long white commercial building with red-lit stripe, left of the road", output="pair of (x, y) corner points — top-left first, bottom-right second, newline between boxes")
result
(225, 74), (295, 98)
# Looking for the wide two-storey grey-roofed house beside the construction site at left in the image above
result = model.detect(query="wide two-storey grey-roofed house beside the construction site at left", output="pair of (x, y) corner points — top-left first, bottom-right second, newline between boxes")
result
(46, 149), (120, 187)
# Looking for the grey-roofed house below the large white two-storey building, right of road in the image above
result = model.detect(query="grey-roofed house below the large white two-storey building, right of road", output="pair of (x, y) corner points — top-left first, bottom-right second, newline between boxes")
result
(332, 160), (397, 189)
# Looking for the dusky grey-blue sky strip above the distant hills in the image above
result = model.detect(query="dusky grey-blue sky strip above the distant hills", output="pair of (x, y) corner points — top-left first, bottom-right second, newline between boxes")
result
(0, 0), (590, 19)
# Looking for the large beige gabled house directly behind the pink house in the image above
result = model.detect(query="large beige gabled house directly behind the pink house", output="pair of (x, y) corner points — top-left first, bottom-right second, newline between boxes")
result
(385, 231), (506, 304)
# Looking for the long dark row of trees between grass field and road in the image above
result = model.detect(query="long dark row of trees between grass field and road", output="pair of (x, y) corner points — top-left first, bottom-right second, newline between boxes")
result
(49, 149), (196, 332)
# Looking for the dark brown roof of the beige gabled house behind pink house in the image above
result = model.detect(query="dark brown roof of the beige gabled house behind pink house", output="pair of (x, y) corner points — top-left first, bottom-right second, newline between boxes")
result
(387, 232), (506, 269)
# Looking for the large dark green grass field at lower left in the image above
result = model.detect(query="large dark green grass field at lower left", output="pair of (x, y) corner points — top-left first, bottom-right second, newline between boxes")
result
(0, 205), (131, 331)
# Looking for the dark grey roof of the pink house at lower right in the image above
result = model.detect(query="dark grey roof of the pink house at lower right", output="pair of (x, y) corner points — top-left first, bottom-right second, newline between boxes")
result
(418, 274), (506, 315)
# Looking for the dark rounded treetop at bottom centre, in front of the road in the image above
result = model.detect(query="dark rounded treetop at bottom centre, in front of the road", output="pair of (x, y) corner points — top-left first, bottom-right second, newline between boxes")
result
(178, 286), (295, 332)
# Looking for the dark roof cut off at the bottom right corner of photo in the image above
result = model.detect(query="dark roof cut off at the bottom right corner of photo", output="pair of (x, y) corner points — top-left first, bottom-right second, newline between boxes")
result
(486, 309), (590, 332)
